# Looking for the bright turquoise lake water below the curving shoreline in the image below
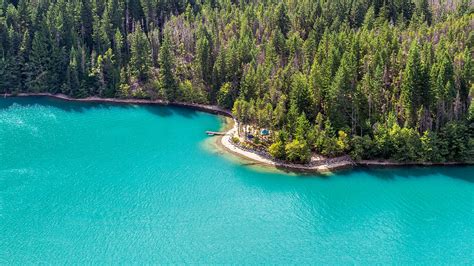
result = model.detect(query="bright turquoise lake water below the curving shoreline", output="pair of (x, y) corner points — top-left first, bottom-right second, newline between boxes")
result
(0, 98), (474, 265)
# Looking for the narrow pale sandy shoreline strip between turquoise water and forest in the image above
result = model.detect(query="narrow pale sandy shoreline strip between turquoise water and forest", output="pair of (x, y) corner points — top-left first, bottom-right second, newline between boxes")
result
(1, 93), (474, 174)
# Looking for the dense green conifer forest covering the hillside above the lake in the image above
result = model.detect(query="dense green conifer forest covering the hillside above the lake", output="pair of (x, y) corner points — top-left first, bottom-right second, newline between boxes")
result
(0, 0), (474, 162)
